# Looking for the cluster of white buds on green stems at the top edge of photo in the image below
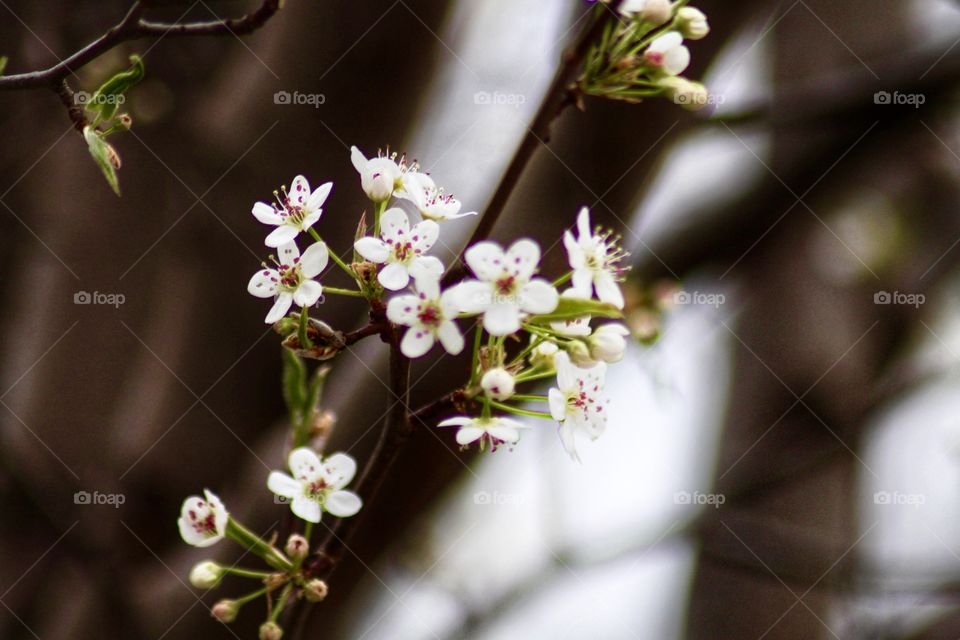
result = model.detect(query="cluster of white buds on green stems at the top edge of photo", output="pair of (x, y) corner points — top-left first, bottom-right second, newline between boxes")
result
(581, 0), (710, 110)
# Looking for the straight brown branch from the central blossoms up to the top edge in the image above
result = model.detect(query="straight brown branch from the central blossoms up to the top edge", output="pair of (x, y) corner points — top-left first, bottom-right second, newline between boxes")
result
(443, 0), (624, 284)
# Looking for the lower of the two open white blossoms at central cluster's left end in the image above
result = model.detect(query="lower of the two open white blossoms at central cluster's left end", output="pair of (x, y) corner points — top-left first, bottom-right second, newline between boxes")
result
(247, 242), (330, 324)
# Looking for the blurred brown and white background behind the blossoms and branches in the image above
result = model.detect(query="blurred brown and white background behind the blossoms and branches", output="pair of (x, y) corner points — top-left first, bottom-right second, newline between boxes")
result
(0, 0), (960, 640)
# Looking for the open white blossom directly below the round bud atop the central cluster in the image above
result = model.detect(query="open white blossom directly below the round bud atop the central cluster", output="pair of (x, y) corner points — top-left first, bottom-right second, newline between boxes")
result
(354, 207), (443, 291)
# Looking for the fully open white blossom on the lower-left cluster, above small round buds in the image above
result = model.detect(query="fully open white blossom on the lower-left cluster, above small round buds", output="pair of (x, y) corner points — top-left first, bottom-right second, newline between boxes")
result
(267, 447), (363, 522)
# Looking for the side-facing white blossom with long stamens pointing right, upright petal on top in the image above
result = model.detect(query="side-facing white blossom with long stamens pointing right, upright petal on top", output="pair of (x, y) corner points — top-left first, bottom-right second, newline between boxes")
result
(563, 207), (626, 309)
